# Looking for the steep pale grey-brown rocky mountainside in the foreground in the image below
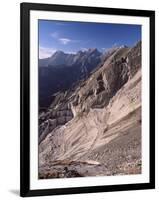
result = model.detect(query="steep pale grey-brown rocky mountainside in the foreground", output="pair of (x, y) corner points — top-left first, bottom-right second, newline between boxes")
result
(39, 42), (141, 178)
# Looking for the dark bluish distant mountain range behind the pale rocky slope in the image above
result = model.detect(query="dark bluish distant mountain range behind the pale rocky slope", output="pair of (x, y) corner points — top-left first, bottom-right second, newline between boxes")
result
(39, 48), (105, 107)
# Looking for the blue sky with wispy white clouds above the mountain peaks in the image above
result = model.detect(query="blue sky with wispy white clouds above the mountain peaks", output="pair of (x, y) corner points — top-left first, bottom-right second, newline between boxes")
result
(39, 20), (141, 58)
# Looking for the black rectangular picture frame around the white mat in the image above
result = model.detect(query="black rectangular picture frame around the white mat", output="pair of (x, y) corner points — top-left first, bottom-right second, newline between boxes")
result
(20, 3), (155, 197)
